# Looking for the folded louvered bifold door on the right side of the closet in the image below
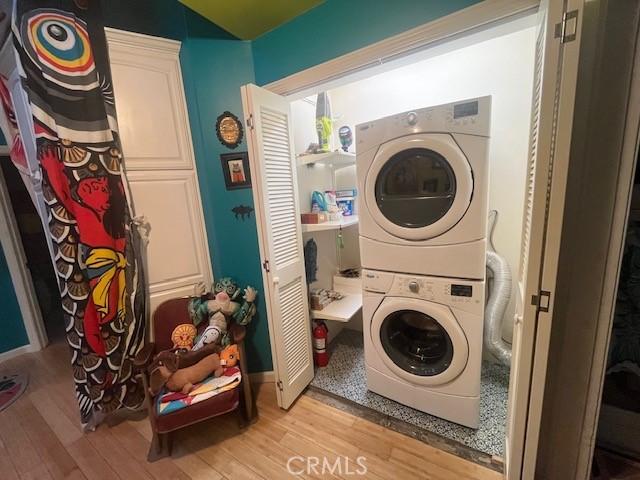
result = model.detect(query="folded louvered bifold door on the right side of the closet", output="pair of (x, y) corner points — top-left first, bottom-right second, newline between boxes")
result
(505, 0), (582, 480)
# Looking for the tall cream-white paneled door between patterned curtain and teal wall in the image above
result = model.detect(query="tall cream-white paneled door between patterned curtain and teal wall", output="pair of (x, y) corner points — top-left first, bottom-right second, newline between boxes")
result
(107, 29), (213, 312)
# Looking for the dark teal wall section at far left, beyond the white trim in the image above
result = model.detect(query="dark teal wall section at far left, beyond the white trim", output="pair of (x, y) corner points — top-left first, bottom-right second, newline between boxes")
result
(0, 247), (29, 353)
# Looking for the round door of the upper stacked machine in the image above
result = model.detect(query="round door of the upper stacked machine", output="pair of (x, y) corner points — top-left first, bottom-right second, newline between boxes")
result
(365, 134), (473, 240)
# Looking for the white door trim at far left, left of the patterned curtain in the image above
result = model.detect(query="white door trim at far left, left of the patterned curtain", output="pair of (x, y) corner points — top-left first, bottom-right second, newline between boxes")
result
(0, 152), (49, 355)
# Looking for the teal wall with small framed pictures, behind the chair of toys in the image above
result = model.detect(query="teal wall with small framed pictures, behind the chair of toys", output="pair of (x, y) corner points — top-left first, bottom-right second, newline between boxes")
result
(180, 38), (272, 372)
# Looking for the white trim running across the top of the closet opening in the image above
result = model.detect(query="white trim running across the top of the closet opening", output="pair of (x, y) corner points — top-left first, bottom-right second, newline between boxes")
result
(264, 0), (540, 96)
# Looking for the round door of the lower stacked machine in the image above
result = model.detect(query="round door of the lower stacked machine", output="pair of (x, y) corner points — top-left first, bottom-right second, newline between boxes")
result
(371, 297), (469, 385)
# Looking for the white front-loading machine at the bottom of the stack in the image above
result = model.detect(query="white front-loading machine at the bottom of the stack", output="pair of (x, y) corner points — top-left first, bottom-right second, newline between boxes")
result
(362, 270), (485, 428)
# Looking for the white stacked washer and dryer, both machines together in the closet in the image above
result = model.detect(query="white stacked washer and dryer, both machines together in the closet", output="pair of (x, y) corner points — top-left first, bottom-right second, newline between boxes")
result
(356, 97), (491, 428)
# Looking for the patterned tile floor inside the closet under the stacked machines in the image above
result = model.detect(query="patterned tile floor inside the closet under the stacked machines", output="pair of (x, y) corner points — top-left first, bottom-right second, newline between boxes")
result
(311, 330), (509, 456)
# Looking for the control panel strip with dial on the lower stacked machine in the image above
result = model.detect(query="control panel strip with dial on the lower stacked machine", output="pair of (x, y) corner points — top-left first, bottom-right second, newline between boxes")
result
(362, 270), (485, 313)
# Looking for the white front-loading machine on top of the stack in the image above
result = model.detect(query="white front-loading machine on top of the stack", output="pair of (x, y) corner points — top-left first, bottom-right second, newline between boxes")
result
(356, 97), (491, 279)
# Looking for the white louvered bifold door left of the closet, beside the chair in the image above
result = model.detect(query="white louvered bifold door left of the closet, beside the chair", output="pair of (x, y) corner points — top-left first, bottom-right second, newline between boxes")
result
(242, 85), (313, 408)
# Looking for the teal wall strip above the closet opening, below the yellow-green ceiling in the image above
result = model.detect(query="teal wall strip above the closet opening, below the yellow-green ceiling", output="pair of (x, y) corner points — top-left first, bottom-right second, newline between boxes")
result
(252, 0), (480, 85)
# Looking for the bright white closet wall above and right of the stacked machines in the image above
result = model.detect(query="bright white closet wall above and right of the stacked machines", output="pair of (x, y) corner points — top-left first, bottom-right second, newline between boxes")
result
(322, 27), (535, 340)
